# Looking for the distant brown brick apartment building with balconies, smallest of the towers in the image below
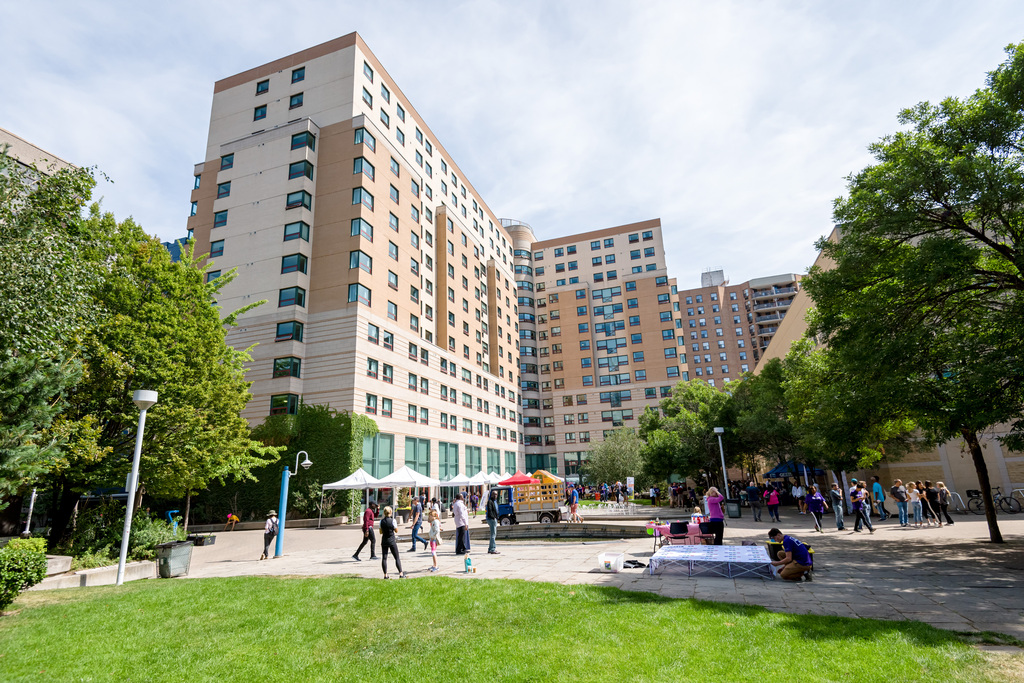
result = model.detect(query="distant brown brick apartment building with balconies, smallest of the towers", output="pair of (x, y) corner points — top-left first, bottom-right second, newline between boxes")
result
(677, 270), (801, 387)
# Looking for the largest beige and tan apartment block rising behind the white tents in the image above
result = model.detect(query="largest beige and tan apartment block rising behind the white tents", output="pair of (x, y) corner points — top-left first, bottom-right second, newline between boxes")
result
(188, 33), (522, 479)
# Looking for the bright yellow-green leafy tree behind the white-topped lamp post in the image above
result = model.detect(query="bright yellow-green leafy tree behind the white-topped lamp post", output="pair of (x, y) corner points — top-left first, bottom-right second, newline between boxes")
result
(49, 216), (278, 538)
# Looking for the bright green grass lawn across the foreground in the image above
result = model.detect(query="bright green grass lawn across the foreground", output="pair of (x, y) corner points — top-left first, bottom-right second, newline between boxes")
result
(0, 577), (997, 683)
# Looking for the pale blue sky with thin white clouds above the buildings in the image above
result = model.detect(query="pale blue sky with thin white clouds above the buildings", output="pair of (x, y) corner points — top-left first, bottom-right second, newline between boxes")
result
(0, 0), (1024, 289)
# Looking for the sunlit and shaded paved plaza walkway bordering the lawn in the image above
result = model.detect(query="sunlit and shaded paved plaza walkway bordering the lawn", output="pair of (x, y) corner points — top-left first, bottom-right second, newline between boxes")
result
(180, 509), (1024, 640)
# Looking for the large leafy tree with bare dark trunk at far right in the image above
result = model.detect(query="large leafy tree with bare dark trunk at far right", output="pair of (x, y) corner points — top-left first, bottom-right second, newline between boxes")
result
(805, 45), (1024, 542)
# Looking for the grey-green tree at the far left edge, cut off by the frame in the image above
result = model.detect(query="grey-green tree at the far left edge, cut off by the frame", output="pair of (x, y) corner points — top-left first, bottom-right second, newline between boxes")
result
(0, 150), (98, 509)
